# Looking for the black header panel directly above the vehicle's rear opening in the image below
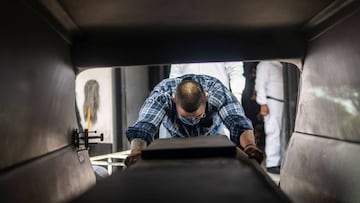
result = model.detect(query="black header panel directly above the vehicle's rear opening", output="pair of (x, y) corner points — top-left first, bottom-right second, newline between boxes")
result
(72, 27), (306, 67)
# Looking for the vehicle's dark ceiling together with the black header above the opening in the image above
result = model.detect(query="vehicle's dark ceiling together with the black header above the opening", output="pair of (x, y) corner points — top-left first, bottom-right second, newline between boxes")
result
(38, 0), (353, 66)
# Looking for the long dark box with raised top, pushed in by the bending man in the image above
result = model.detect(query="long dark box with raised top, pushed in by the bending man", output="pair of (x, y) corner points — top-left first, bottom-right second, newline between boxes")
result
(73, 136), (290, 203)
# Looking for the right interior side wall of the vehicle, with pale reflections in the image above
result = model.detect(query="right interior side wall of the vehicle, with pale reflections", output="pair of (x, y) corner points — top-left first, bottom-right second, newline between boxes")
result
(280, 6), (360, 202)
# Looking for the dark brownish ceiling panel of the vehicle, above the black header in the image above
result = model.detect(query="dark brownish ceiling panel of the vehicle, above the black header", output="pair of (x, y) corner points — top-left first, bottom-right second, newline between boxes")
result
(42, 0), (336, 32)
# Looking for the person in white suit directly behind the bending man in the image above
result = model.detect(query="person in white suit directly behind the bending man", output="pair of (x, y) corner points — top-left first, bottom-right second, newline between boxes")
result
(159, 61), (245, 138)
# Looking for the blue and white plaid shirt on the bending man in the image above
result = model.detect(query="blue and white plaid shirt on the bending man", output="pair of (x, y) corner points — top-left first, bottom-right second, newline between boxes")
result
(126, 74), (252, 146)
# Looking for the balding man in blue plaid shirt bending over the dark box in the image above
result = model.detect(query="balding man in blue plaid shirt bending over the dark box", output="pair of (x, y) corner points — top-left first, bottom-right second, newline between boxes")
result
(126, 74), (263, 166)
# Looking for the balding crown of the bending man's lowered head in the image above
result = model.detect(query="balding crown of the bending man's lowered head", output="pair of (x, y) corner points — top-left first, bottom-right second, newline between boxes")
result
(175, 80), (206, 113)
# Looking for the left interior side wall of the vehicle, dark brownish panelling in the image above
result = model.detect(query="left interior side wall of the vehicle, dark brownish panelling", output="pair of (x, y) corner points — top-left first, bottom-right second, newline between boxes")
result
(0, 1), (95, 203)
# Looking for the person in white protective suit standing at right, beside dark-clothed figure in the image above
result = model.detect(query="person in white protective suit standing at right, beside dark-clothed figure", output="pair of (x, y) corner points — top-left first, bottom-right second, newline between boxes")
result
(255, 61), (284, 174)
